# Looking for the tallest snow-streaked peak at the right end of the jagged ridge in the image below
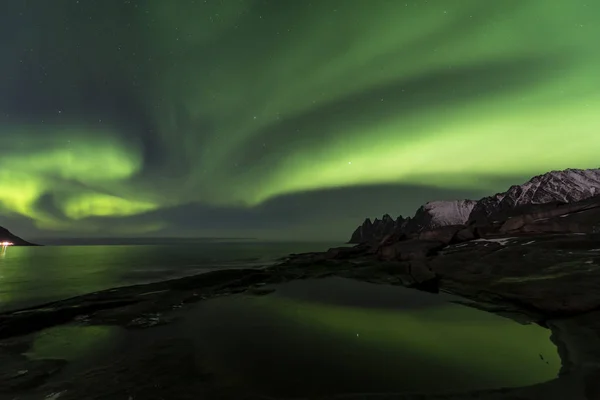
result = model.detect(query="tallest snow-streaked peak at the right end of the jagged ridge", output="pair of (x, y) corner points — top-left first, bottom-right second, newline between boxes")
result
(469, 169), (600, 223)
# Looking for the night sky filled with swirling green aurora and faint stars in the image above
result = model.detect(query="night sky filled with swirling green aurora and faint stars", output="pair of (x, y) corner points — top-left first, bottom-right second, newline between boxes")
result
(0, 0), (600, 240)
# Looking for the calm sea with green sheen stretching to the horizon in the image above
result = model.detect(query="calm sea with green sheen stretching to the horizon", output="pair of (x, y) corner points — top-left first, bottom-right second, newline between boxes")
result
(0, 238), (342, 312)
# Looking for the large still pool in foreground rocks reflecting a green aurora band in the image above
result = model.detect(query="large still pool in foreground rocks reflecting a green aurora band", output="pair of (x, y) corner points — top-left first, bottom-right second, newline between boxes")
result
(185, 278), (560, 396)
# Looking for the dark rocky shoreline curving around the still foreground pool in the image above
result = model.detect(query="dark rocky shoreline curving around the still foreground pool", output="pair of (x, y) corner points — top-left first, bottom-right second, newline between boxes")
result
(0, 197), (600, 400)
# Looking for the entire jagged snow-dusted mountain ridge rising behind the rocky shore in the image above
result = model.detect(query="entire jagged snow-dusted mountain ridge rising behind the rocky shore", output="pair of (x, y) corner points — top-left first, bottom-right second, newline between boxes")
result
(350, 169), (600, 243)
